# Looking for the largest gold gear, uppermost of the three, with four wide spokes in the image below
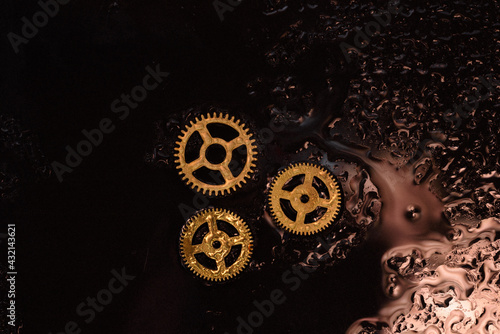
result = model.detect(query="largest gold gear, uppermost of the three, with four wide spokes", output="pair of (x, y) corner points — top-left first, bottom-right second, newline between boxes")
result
(175, 113), (257, 196)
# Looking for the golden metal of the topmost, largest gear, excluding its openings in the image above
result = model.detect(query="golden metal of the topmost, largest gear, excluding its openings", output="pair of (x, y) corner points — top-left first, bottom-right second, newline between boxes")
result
(175, 113), (257, 196)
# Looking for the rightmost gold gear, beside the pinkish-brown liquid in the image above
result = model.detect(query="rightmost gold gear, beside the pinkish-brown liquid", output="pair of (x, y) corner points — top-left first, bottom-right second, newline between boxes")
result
(268, 163), (343, 235)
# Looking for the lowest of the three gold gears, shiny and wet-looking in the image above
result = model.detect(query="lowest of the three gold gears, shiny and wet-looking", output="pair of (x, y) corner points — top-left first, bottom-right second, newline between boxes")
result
(180, 209), (253, 281)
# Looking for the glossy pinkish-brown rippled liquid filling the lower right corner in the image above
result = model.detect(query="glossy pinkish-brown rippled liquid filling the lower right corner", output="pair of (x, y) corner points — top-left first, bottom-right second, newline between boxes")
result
(278, 105), (500, 333)
